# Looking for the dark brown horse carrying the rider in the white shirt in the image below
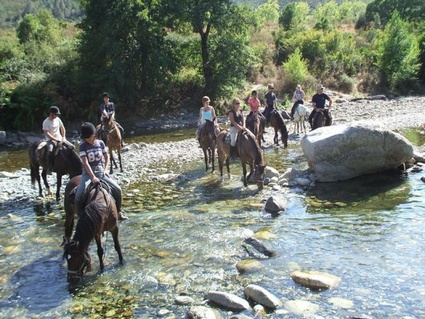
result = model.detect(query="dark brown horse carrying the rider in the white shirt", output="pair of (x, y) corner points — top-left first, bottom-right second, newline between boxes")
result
(28, 141), (82, 201)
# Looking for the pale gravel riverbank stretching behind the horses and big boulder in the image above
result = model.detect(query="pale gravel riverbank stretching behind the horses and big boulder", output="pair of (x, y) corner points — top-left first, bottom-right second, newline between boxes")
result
(0, 94), (425, 204)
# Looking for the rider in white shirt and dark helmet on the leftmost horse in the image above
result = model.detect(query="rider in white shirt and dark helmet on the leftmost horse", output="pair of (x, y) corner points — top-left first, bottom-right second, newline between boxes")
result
(43, 106), (74, 175)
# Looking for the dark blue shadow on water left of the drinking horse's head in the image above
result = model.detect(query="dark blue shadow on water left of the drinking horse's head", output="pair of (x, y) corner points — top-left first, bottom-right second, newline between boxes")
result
(0, 250), (69, 314)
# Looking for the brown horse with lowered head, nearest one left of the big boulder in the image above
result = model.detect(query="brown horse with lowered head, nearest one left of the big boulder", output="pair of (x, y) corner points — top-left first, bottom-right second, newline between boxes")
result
(217, 130), (266, 190)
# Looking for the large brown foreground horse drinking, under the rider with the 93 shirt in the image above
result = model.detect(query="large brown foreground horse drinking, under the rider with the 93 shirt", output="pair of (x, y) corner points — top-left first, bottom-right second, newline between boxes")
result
(63, 176), (124, 285)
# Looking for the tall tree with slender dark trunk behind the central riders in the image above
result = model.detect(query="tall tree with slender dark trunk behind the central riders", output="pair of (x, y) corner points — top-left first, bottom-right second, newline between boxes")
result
(164, 0), (252, 98)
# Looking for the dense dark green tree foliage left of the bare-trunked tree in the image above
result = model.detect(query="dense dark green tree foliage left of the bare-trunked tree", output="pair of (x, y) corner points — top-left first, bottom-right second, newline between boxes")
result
(80, 0), (173, 112)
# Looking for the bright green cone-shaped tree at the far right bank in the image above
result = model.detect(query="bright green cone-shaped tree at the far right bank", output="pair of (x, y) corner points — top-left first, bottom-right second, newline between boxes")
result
(377, 11), (420, 93)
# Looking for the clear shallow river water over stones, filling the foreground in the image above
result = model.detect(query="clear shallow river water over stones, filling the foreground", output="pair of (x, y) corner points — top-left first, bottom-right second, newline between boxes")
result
(0, 129), (425, 319)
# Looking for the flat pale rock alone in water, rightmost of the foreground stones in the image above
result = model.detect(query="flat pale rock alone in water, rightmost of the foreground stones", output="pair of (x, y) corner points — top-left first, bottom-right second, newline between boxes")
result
(291, 271), (341, 290)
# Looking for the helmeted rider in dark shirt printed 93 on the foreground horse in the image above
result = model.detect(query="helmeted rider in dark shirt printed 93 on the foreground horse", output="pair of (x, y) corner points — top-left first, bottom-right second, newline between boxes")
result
(75, 122), (127, 220)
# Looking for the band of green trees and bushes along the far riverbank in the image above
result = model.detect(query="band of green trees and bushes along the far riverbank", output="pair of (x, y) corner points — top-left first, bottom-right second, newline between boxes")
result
(0, 0), (425, 130)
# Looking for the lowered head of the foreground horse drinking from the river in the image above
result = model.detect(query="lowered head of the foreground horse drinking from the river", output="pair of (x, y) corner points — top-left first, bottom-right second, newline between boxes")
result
(63, 240), (91, 285)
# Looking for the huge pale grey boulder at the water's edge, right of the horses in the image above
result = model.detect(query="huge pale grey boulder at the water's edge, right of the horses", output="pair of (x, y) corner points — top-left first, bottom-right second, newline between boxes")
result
(300, 121), (413, 182)
